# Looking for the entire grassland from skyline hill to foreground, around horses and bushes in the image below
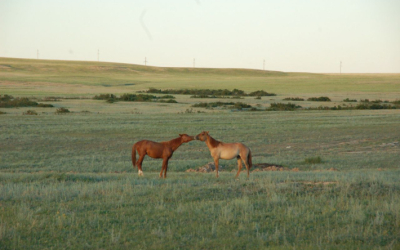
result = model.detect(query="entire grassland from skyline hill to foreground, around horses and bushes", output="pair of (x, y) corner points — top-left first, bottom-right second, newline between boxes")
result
(0, 58), (400, 249)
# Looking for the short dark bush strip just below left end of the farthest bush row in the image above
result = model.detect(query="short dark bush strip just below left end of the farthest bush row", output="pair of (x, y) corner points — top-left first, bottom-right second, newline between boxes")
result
(93, 94), (178, 103)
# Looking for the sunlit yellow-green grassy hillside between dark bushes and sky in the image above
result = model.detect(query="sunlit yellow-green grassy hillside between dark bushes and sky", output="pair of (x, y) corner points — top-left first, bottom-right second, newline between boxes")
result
(0, 58), (400, 96)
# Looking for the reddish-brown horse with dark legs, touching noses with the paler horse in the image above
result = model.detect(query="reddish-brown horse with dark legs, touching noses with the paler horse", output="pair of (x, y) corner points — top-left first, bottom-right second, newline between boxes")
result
(132, 134), (194, 178)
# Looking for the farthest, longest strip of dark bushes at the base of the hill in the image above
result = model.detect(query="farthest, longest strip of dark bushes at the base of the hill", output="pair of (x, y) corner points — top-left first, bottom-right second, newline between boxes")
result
(144, 88), (276, 96)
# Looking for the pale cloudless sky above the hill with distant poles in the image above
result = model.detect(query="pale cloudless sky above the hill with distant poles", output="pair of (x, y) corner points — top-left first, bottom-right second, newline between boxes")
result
(0, 0), (400, 73)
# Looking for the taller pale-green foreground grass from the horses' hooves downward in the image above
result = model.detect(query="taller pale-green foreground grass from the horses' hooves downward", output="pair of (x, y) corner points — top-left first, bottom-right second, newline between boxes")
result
(0, 170), (400, 249)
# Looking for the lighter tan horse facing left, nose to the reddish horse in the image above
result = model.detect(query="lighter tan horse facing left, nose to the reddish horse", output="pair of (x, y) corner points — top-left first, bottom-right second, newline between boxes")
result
(195, 131), (252, 178)
